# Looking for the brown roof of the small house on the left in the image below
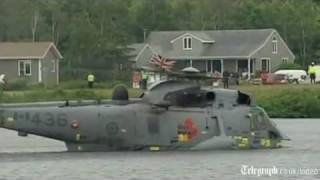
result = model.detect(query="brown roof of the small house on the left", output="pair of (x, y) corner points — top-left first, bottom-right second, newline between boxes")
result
(0, 42), (62, 59)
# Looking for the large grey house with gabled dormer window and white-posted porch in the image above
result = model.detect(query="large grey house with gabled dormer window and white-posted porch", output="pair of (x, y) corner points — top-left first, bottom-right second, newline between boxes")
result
(130, 29), (295, 79)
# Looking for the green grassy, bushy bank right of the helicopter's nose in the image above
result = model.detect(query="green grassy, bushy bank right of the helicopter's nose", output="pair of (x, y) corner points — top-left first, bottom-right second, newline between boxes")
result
(241, 85), (320, 118)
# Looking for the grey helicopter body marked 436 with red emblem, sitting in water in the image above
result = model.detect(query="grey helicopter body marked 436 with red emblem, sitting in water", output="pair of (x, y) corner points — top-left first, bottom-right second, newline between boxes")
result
(0, 81), (287, 151)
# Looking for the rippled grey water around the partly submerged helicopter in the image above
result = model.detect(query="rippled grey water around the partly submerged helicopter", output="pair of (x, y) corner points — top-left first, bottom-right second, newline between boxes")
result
(0, 119), (320, 180)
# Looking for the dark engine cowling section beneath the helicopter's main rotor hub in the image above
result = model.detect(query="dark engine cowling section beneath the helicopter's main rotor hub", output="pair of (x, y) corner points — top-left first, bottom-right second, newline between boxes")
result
(164, 91), (215, 107)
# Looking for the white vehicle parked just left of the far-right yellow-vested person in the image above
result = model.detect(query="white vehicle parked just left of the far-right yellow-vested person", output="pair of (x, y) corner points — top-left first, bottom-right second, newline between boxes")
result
(274, 69), (306, 84)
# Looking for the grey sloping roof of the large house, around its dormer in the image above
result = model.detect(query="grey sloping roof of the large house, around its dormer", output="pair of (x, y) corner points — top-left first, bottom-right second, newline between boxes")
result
(138, 29), (276, 59)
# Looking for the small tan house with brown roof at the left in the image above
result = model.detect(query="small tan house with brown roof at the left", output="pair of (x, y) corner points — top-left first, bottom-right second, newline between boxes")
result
(0, 42), (62, 85)
